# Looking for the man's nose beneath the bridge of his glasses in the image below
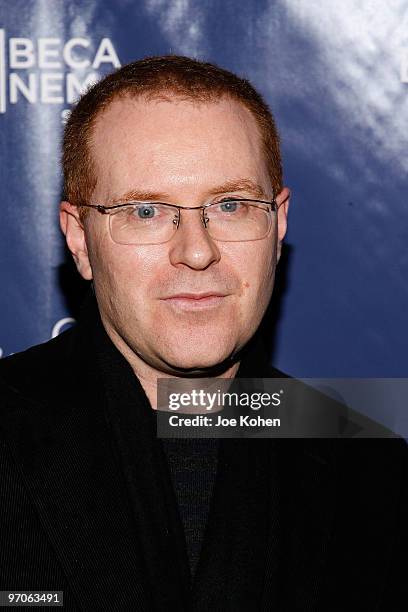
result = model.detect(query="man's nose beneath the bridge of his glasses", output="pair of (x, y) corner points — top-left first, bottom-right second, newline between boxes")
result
(169, 209), (221, 270)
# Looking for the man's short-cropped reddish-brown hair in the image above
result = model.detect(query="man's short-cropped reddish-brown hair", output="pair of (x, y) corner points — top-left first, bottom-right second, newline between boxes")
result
(62, 55), (282, 216)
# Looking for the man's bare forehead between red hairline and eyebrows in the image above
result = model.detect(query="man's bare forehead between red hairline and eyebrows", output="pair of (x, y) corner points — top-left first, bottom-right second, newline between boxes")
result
(91, 97), (268, 198)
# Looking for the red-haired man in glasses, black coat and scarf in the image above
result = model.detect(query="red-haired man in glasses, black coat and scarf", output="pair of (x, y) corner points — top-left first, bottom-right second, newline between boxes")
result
(0, 56), (407, 611)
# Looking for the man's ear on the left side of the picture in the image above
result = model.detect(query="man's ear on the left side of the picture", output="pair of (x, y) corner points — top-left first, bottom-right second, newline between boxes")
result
(60, 202), (92, 280)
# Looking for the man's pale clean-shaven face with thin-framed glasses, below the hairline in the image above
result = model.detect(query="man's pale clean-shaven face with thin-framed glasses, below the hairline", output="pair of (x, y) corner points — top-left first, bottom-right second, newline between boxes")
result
(62, 97), (287, 374)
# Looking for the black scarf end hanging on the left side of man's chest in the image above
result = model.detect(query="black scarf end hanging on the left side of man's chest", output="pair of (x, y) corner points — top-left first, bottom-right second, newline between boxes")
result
(95, 314), (190, 612)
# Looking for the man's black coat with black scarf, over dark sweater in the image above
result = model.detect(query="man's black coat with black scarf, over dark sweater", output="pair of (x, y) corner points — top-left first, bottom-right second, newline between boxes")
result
(0, 298), (408, 612)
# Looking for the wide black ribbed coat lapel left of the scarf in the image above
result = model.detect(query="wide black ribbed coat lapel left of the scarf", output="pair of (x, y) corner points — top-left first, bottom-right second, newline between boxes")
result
(1, 352), (150, 610)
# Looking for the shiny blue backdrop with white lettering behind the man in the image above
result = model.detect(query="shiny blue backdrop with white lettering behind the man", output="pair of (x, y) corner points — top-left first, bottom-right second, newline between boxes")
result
(0, 0), (408, 377)
